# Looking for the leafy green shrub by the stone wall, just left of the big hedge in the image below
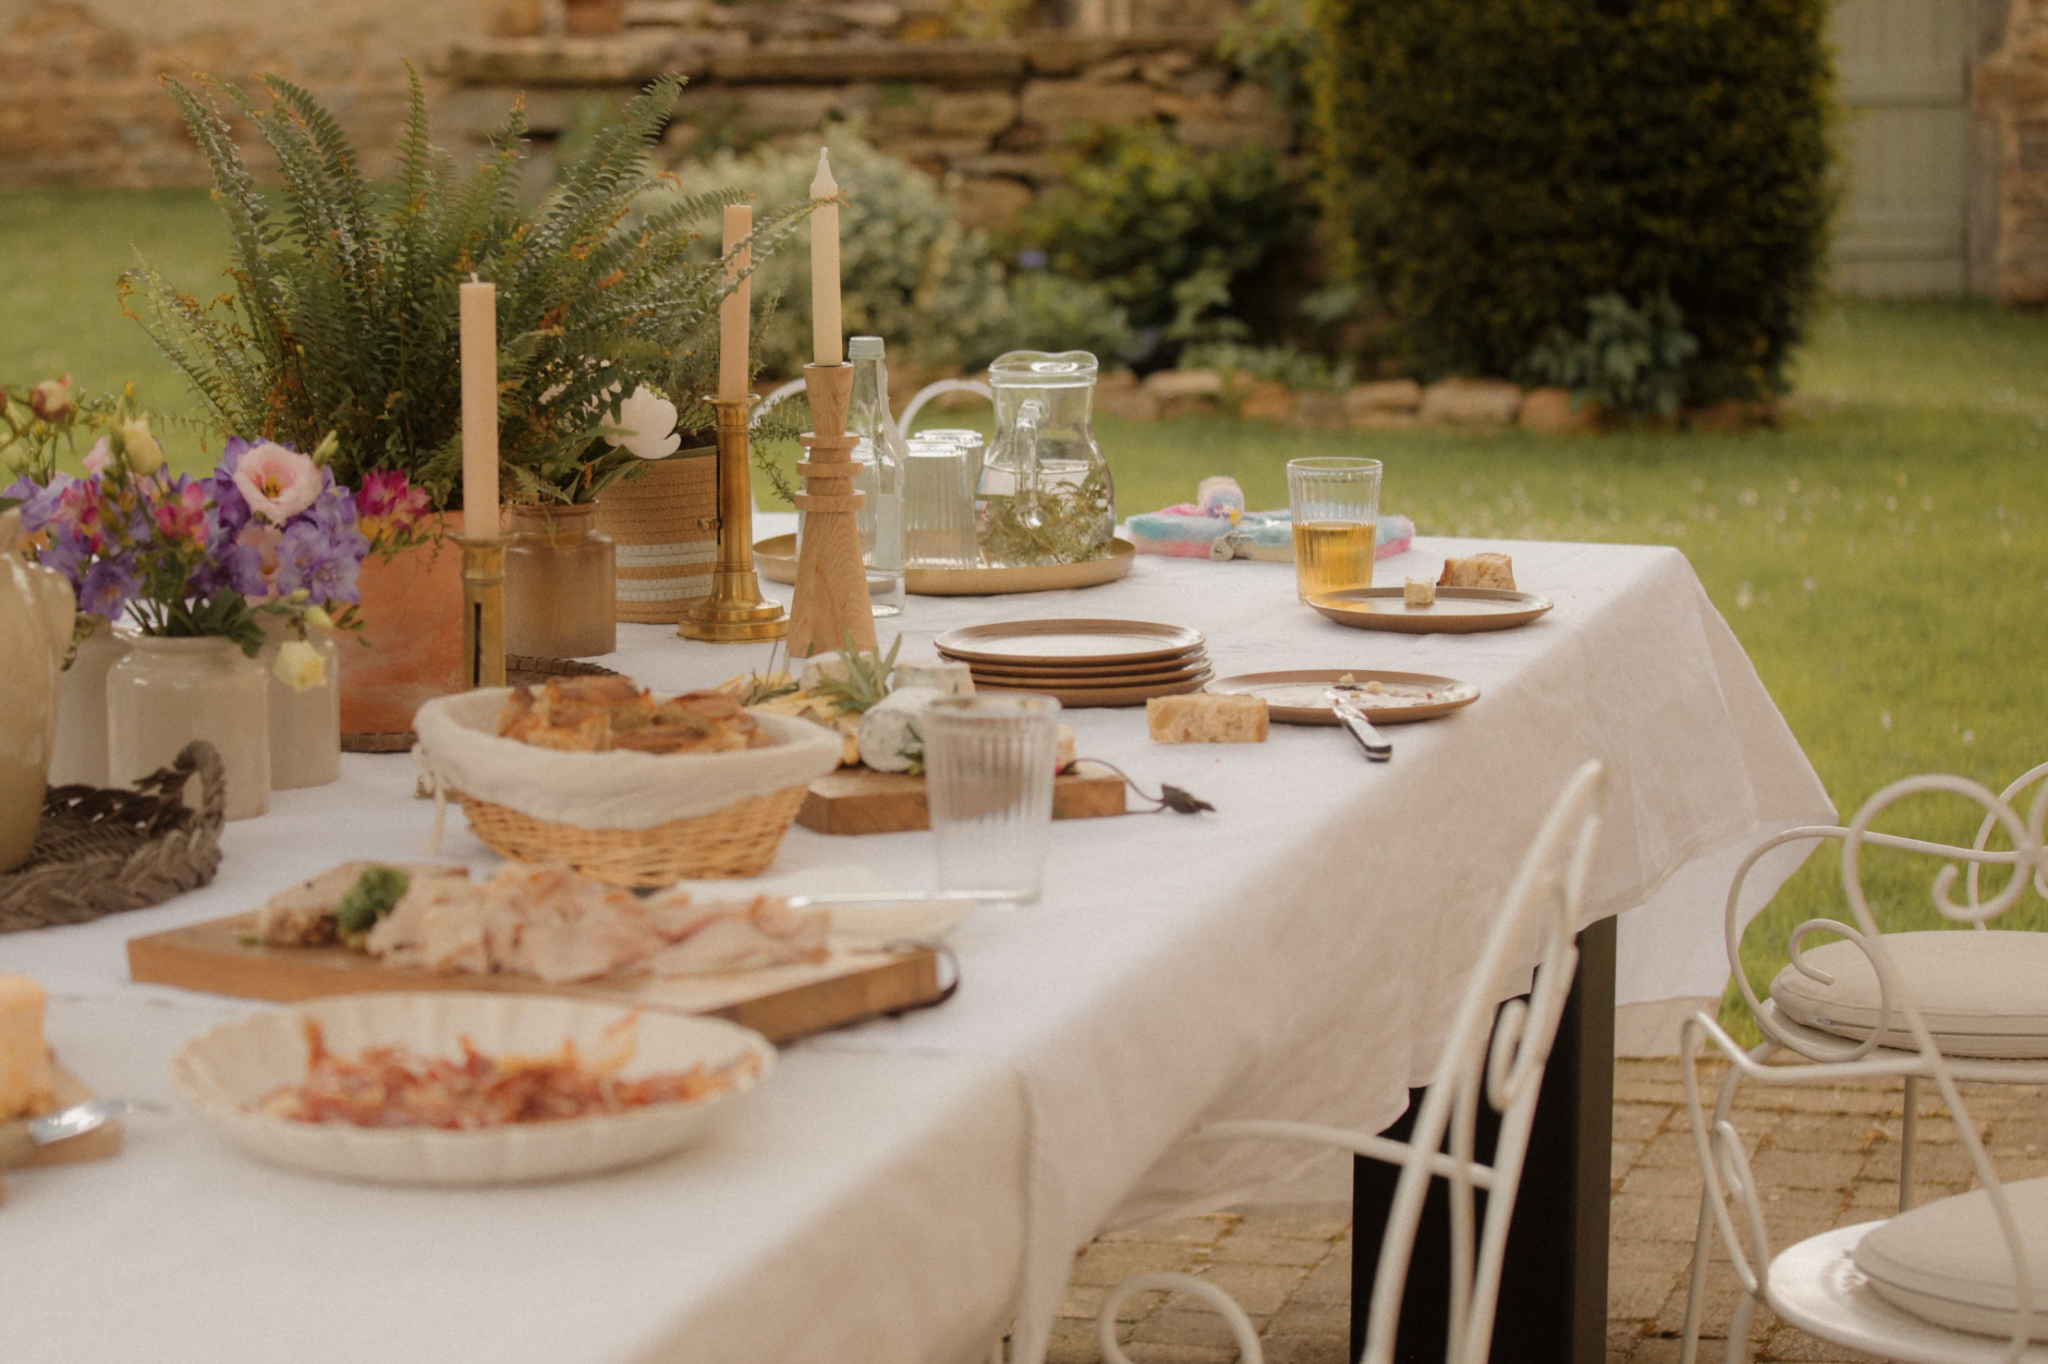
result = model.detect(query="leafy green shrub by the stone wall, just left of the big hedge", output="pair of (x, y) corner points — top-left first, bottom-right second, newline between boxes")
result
(1020, 125), (1311, 352)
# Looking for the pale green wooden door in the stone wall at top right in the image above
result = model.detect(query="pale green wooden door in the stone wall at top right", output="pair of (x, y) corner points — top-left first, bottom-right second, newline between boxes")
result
(1833, 0), (1970, 297)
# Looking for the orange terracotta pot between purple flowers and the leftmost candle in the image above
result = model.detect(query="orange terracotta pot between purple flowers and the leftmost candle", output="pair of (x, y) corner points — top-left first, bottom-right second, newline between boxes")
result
(340, 514), (463, 733)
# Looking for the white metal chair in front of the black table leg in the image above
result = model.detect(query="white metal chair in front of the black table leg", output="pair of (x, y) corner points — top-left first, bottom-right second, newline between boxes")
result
(1096, 762), (1606, 1364)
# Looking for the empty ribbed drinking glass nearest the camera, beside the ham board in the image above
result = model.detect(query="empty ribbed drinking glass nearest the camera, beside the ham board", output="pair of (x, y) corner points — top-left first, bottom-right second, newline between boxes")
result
(924, 696), (1059, 903)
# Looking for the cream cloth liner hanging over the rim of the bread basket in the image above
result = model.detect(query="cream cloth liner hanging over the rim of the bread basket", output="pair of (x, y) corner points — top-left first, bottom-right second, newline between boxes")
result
(412, 686), (840, 829)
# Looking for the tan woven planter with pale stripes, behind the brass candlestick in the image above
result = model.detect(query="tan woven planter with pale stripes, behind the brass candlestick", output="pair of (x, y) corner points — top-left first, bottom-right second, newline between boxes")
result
(598, 455), (719, 625)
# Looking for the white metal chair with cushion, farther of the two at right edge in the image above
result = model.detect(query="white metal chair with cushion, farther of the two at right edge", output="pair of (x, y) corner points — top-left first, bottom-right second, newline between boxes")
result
(1679, 764), (2048, 1364)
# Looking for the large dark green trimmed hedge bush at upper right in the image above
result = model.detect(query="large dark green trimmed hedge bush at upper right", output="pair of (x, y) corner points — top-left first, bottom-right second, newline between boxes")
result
(1311, 0), (1833, 401)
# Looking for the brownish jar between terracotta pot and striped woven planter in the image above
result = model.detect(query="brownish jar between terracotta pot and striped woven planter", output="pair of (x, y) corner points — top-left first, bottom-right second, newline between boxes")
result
(506, 504), (618, 657)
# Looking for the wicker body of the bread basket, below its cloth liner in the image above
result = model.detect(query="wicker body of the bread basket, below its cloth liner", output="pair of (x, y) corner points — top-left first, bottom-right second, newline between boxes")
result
(461, 786), (809, 887)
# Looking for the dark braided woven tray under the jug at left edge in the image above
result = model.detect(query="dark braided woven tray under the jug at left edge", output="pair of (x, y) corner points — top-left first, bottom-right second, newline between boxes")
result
(0, 739), (227, 932)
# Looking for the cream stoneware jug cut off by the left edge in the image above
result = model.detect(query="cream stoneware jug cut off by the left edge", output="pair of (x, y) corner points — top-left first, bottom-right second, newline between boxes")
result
(0, 508), (74, 872)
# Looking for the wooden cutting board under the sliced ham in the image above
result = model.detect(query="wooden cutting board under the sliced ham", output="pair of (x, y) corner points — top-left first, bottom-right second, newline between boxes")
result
(129, 913), (940, 1042)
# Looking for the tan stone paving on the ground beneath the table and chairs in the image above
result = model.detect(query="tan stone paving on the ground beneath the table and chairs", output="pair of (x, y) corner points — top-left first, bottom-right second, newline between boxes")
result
(1051, 1061), (2048, 1364)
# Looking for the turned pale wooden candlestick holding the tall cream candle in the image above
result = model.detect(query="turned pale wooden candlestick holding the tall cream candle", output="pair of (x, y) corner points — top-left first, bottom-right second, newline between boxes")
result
(788, 363), (874, 657)
